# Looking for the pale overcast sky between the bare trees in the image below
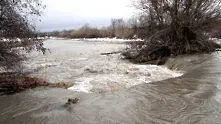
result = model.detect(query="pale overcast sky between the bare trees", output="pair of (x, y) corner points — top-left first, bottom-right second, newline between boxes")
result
(37, 0), (135, 31)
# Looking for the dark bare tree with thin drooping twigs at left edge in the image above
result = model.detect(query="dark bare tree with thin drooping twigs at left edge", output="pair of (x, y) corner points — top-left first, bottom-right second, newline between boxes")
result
(0, 0), (45, 69)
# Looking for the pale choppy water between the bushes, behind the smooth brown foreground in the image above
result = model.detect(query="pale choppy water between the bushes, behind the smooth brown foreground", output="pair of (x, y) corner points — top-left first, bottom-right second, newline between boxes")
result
(25, 39), (183, 93)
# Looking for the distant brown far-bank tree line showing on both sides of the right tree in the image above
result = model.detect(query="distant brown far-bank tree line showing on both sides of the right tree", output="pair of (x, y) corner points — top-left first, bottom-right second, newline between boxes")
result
(40, 16), (221, 39)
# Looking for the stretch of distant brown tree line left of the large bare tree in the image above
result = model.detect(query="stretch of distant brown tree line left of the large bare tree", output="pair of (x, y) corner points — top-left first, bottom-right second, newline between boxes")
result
(40, 17), (138, 39)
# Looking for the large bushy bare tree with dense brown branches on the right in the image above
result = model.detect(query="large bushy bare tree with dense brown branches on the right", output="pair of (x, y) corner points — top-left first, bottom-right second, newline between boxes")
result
(123, 0), (221, 64)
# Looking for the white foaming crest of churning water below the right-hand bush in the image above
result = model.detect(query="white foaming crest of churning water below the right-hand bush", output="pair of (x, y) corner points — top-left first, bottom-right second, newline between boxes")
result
(69, 64), (183, 93)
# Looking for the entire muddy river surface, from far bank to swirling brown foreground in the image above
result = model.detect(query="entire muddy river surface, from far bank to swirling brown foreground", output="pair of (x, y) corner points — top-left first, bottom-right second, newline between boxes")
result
(0, 40), (221, 124)
